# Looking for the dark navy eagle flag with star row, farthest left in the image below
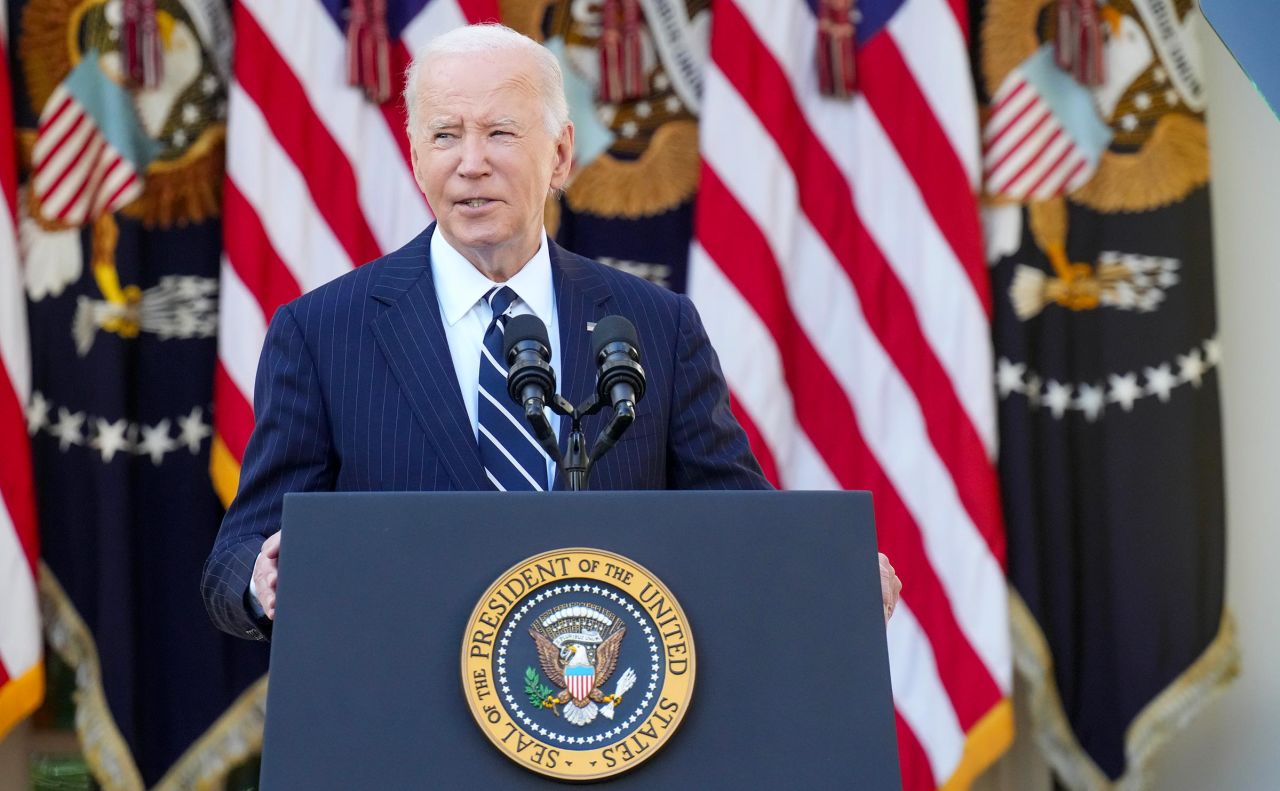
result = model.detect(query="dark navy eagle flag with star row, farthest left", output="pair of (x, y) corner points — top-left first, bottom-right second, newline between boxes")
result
(8, 0), (266, 788)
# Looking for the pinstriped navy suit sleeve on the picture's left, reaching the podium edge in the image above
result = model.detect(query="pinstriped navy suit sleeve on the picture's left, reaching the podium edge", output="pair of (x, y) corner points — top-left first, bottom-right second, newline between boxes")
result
(201, 306), (338, 640)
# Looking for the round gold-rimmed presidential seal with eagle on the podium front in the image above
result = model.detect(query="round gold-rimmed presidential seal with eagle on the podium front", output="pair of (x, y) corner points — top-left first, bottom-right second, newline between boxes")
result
(462, 549), (695, 781)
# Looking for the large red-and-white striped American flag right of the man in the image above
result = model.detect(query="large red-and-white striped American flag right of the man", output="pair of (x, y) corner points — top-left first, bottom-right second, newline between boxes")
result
(689, 0), (1012, 790)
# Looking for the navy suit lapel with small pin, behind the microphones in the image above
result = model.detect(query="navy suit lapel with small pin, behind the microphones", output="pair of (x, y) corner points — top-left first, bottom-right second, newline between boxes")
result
(548, 241), (612, 490)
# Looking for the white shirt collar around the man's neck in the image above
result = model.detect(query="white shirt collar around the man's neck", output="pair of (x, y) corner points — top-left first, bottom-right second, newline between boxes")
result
(431, 228), (554, 326)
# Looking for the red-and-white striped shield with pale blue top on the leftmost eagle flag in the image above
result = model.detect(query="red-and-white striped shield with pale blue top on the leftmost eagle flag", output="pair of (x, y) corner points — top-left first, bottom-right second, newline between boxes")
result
(32, 51), (157, 225)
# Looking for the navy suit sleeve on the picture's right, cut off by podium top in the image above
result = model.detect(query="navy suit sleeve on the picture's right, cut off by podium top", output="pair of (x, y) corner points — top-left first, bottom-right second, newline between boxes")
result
(667, 296), (773, 489)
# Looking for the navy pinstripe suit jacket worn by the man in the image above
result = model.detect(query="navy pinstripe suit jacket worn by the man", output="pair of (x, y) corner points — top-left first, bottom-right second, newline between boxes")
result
(202, 225), (769, 639)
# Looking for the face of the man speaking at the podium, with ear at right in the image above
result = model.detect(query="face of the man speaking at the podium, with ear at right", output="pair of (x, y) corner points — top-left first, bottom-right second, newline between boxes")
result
(411, 51), (573, 272)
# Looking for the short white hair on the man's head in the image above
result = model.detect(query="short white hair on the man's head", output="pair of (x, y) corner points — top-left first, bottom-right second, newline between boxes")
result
(404, 23), (568, 140)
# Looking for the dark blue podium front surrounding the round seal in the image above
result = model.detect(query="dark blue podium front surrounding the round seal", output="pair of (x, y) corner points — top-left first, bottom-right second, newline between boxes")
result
(261, 491), (901, 791)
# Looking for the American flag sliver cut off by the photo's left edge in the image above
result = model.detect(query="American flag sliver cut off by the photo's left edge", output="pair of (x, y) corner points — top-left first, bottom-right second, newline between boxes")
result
(0, 0), (45, 741)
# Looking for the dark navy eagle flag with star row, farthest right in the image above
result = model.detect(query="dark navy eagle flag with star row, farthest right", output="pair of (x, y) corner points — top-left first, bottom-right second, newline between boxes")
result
(982, 0), (1239, 788)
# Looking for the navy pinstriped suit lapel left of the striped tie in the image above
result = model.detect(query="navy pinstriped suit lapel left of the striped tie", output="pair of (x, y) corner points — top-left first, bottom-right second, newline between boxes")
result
(371, 224), (493, 490)
